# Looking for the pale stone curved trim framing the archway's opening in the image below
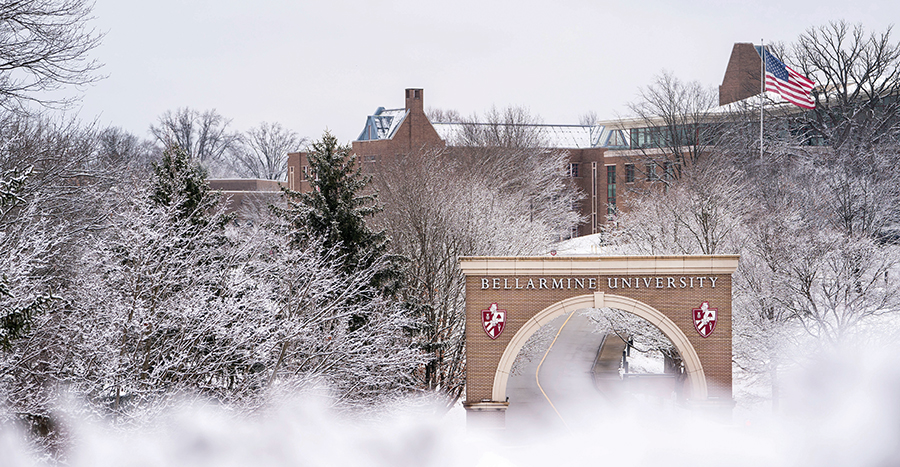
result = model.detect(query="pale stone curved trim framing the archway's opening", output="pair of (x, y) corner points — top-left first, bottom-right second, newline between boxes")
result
(492, 292), (708, 401)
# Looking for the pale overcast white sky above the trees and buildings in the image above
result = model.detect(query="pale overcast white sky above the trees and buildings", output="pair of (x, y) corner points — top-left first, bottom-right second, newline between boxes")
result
(79, 0), (900, 142)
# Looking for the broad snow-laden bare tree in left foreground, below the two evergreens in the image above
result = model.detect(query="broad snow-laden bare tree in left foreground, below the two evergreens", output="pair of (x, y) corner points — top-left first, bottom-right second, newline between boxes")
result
(2, 162), (421, 432)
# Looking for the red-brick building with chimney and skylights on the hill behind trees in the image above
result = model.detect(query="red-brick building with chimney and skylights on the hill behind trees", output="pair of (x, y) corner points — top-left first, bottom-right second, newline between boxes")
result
(287, 43), (776, 236)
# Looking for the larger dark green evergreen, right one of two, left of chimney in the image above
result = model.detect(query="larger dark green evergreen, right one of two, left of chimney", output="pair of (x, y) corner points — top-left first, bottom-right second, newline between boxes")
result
(281, 132), (393, 285)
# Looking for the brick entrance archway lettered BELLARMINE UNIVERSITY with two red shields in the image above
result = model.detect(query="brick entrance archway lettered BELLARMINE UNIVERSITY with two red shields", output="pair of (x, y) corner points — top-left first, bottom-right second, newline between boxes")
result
(460, 255), (739, 428)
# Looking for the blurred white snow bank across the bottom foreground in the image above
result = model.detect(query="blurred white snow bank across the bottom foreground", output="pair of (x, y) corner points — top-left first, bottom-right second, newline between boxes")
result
(0, 336), (900, 467)
